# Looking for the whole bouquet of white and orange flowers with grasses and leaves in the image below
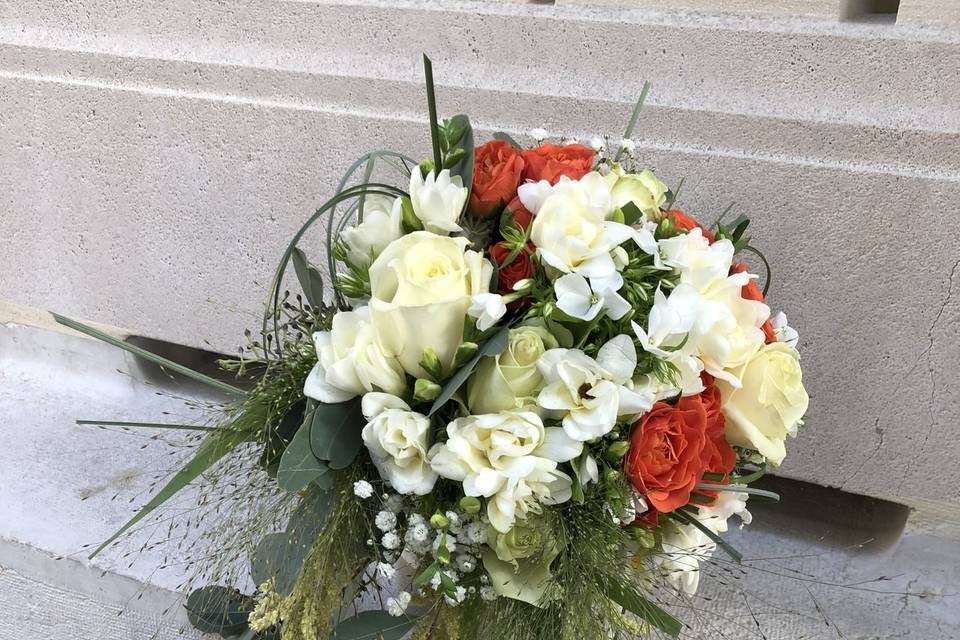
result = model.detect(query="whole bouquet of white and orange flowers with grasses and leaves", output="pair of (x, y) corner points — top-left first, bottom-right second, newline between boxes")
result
(57, 60), (808, 640)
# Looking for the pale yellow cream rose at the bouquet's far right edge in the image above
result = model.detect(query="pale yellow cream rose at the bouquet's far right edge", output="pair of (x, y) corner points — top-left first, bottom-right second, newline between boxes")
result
(717, 342), (810, 466)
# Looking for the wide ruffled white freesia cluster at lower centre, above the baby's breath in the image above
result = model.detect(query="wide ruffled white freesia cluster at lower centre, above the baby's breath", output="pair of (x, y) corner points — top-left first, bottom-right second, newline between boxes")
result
(431, 410), (582, 533)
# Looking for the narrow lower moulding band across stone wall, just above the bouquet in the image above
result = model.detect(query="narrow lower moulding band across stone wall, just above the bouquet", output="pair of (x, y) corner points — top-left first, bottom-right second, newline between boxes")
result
(0, 44), (960, 181)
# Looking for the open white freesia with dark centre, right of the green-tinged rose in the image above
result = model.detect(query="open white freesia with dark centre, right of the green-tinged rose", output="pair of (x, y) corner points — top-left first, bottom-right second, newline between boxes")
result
(537, 335), (652, 442)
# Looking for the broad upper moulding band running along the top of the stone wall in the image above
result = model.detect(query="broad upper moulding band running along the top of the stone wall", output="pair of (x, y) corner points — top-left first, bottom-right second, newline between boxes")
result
(0, 0), (960, 132)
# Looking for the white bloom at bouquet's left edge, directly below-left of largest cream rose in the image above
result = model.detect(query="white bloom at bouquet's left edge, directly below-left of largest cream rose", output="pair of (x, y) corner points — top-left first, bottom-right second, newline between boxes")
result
(303, 307), (406, 403)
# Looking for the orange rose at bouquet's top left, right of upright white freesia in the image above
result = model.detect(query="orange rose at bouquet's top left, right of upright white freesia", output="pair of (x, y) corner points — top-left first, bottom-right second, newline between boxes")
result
(469, 140), (524, 217)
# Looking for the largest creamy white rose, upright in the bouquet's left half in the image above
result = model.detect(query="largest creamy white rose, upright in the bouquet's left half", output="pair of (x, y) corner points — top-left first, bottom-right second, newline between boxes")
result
(370, 231), (493, 378)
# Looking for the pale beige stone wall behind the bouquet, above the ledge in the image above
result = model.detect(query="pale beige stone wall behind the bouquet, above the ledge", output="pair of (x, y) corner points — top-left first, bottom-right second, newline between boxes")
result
(0, 0), (960, 504)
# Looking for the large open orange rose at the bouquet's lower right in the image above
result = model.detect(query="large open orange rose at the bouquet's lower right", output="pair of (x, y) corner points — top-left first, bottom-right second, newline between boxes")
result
(624, 396), (712, 513)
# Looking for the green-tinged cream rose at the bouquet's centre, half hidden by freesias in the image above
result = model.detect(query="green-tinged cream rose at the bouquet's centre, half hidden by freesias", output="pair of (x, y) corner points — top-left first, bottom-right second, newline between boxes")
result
(467, 326), (560, 413)
